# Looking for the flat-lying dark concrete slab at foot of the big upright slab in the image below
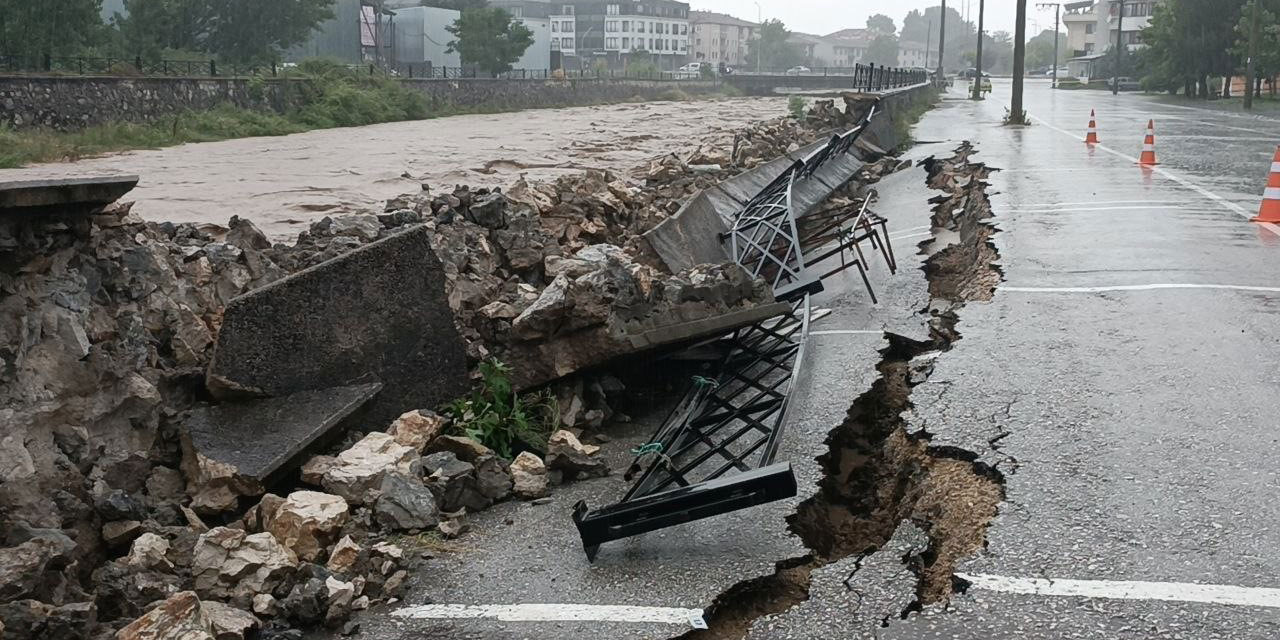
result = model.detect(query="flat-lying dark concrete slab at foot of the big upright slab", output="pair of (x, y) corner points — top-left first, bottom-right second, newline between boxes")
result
(183, 383), (381, 484)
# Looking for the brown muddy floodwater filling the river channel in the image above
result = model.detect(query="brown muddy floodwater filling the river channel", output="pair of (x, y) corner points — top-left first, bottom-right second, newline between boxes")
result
(0, 97), (786, 239)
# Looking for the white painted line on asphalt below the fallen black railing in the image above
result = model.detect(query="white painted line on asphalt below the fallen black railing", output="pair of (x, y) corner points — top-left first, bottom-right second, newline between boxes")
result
(392, 604), (707, 628)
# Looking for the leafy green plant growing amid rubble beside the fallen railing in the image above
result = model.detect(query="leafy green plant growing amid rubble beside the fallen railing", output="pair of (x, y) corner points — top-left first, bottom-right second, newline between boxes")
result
(448, 360), (559, 460)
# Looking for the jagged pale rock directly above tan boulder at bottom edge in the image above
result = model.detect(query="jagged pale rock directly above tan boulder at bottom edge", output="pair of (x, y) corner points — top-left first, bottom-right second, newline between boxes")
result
(191, 527), (298, 599)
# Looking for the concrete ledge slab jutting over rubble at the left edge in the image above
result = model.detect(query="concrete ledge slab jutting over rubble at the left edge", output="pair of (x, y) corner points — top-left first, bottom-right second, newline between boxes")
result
(0, 175), (138, 214)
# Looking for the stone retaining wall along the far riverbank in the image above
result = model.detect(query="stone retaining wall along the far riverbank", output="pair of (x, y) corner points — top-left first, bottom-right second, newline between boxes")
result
(0, 76), (717, 131)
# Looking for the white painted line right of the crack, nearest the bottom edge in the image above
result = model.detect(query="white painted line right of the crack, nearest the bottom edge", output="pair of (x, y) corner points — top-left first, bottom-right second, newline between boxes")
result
(956, 573), (1280, 607)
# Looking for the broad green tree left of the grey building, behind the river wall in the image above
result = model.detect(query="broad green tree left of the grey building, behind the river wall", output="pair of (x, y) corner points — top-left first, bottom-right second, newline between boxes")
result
(116, 0), (333, 63)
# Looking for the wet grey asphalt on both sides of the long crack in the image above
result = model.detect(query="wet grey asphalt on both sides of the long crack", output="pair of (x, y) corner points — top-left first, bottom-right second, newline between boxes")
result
(348, 81), (1280, 640)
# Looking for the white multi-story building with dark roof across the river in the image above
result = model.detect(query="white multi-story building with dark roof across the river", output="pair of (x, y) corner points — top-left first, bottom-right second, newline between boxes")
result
(550, 0), (690, 70)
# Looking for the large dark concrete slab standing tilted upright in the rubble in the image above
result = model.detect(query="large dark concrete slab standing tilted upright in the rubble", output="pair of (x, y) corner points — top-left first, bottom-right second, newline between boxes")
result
(207, 225), (470, 426)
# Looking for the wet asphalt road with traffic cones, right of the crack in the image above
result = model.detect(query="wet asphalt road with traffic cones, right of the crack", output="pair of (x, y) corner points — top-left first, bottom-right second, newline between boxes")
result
(753, 82), (1280, 640)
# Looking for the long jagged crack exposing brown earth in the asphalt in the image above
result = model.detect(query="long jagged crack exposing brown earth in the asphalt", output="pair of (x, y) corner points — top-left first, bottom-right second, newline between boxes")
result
(681, 143), (1005, 640)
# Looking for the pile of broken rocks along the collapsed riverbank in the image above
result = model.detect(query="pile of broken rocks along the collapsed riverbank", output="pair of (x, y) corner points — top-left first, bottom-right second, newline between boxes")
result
(0, 93), (880, 640)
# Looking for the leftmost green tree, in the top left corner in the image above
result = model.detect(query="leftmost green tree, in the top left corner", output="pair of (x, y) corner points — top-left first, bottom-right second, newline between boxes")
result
(0, 0), (104, 58)
